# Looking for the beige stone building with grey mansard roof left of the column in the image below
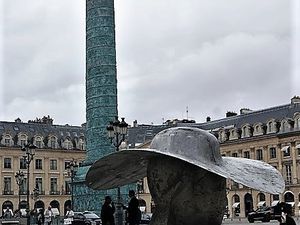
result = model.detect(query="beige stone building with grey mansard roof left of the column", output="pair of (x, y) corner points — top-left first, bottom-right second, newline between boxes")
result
(0, 116), (86, 215)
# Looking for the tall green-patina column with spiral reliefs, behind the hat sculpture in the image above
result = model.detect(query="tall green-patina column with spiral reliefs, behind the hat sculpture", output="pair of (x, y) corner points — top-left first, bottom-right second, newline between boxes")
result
(73, 0), (135, 211)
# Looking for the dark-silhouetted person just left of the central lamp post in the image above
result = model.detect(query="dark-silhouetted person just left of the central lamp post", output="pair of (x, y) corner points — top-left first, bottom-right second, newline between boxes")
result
(101, 196), (116, 225)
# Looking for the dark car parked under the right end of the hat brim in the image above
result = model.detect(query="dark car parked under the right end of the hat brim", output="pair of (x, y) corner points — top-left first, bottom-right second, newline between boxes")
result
(247, 205), (281, 223)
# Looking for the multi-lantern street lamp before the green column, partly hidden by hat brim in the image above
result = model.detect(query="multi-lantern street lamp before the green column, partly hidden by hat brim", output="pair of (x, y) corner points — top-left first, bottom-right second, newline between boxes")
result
(106, 116), (128, 225)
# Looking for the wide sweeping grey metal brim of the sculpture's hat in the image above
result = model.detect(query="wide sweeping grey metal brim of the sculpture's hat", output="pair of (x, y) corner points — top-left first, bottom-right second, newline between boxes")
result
(86, 149), (284, 194)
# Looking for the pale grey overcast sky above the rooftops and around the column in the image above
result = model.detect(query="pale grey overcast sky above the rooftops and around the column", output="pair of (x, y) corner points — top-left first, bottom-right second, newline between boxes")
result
(0, 0), (300, 125)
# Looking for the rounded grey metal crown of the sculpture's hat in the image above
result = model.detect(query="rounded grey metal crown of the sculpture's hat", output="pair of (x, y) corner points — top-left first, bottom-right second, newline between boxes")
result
(150, 127), (222, 164)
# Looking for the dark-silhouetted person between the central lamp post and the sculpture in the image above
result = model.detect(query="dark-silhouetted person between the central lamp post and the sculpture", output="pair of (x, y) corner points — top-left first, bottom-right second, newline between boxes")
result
(124, 190), (142, 225)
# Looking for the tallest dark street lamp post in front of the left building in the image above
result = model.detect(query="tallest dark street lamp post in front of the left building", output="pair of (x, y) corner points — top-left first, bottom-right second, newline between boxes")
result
(22, 144), (36, 225)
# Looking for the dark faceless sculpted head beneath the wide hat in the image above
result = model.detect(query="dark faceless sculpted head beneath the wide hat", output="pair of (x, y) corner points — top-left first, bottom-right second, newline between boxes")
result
(147, 158), (226, 225)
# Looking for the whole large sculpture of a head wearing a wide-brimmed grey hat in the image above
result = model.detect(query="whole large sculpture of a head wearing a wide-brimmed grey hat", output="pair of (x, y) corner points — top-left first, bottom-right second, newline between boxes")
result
(86, 127), (284, 225)
